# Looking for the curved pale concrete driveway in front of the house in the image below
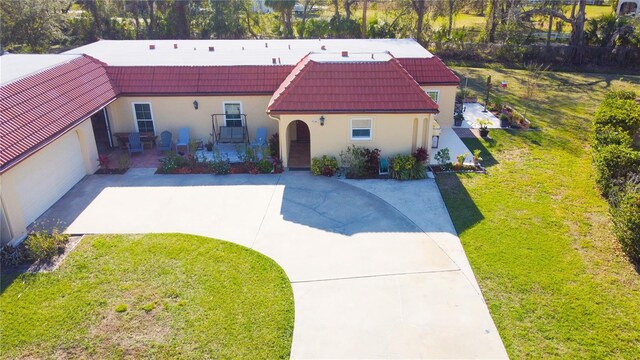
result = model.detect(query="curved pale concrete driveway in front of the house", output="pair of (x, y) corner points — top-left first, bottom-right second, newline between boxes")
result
(43, 169), (507, 358)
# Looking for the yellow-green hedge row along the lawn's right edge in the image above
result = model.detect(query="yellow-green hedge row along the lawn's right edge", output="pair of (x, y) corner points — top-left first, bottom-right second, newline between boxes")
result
(592, 91), (640, 263)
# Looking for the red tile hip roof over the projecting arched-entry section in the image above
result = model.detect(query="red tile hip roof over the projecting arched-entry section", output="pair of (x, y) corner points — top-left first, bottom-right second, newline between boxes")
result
(267, 56), (438, 114)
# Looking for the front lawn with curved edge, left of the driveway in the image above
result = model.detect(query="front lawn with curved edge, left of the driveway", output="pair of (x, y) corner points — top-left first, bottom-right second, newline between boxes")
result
(0, 234), (294, 359)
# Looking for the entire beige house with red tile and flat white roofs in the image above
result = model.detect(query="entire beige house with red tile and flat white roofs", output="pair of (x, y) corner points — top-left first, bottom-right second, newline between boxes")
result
(0, 39), (459, 243)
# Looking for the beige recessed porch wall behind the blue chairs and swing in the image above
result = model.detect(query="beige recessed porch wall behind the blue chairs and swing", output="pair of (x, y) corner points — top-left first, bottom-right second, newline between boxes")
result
(108, 95), (278, 143)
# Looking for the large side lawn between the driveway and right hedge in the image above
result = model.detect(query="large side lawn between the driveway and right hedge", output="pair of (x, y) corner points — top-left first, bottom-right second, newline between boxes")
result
(437, 68), (640, 359)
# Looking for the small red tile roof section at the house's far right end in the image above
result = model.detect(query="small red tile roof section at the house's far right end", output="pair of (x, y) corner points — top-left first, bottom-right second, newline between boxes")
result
(398, 56), (460, 85)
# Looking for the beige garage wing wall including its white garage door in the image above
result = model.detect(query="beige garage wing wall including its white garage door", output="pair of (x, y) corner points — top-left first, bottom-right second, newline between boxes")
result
(0, 119), (98, 245)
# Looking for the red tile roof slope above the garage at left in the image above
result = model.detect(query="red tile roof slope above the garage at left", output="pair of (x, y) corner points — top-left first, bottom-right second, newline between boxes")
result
(0, 55), (117, 172)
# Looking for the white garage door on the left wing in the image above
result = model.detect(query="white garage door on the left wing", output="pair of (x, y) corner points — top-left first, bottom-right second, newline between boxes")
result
(17, 131), (85, 228)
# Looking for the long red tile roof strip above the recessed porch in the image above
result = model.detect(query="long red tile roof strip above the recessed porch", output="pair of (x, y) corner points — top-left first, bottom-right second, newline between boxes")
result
(107, 65), (293, 95)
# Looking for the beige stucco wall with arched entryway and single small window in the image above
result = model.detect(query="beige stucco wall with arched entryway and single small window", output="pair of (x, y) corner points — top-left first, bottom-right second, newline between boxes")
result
(279, 114), (433, 166)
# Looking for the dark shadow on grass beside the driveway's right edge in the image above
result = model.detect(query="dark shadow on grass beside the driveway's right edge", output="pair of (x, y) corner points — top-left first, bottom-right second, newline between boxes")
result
(436, 173), (484, 235)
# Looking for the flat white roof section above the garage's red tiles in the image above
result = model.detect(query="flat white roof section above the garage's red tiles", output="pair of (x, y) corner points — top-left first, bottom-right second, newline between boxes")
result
(0, 54), (81, 85)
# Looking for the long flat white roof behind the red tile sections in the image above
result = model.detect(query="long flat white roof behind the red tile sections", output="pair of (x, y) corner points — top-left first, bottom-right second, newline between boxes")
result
(65, 39), (433, 66)
